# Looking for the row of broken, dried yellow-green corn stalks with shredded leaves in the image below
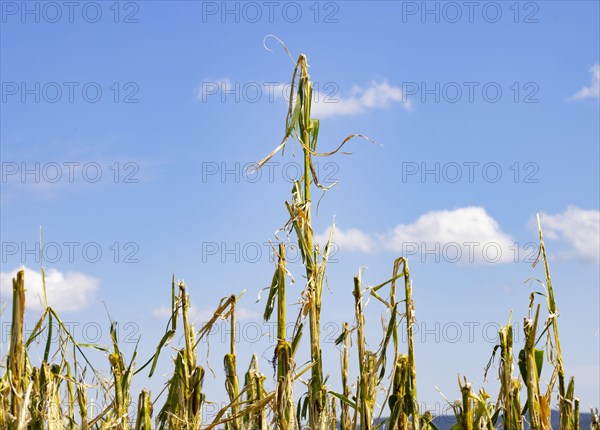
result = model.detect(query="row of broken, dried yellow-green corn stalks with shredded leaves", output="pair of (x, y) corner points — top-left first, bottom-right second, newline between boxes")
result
(0, 55), (600, 430)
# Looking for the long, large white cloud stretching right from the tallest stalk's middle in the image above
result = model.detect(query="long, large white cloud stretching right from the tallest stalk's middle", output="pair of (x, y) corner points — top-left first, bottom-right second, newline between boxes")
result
(316, 207), (514, 263)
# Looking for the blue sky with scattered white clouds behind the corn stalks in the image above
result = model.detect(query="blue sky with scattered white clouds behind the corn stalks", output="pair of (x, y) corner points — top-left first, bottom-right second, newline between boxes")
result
(0, 1), (600, 422)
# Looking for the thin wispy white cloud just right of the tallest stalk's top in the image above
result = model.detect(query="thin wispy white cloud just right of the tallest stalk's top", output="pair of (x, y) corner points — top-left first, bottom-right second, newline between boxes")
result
(312, 81), (411, 118)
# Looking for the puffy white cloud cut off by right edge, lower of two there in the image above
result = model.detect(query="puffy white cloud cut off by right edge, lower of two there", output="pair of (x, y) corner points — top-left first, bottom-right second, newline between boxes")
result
(540, 206), (600, 264)
